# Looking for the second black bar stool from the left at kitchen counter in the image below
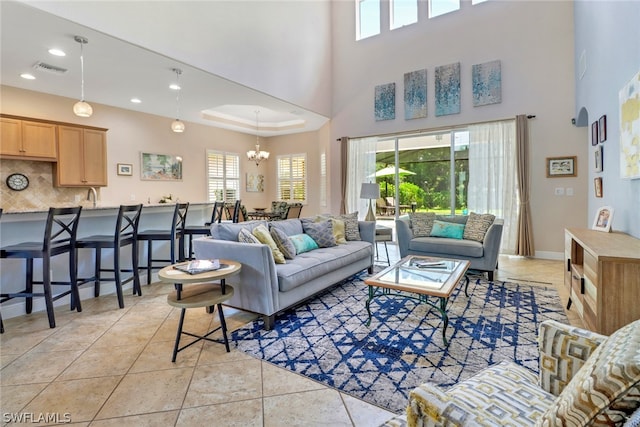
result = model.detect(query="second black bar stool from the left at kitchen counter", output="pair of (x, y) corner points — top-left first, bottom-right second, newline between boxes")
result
(77, 204), (142, 308)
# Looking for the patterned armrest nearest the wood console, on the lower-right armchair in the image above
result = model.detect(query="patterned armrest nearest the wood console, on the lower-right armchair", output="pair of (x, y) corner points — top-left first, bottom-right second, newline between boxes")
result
(538, 320), (607, 396)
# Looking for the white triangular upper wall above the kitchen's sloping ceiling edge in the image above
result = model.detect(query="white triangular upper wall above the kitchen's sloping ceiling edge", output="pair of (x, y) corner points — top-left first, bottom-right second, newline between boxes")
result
(26, 0), (331, 117)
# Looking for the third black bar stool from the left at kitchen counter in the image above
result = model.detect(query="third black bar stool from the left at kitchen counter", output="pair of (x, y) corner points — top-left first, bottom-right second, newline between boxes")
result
(138, 203), (189, 285)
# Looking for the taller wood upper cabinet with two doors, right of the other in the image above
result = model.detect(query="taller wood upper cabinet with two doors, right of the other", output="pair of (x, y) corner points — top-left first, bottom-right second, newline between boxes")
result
(53, 125), (107, 187)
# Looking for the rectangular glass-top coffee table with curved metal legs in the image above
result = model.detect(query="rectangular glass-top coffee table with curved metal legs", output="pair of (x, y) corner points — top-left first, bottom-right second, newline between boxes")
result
(364, 255), (470, 345)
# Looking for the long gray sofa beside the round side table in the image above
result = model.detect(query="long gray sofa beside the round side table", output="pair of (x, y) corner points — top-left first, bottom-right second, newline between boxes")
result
(193, 219), (375, 329)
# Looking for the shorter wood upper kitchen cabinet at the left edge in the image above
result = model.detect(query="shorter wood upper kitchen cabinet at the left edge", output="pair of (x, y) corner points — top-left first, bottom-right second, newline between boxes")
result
(0, 116), (57, 162)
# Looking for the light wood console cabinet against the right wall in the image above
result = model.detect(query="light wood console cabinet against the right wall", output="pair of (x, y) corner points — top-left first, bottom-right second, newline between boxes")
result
(564, 229), (640, 335)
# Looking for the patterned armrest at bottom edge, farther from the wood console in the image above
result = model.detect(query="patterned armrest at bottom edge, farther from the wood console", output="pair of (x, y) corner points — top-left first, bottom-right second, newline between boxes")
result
(407, 383), (465, 427)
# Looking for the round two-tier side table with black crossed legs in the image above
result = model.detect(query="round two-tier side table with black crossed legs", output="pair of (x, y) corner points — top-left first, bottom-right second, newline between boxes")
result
(158, 260), (242, 362)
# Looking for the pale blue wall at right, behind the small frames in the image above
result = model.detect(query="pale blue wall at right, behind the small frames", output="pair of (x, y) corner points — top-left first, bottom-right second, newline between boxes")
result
(575, 0), (640, 238)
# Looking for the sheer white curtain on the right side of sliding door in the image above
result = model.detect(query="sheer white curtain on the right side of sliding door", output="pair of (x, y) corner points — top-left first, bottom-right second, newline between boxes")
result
(467, 120), (520, 254)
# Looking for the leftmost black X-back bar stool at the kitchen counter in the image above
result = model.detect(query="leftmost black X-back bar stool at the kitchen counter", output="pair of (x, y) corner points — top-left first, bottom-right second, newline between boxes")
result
(0, 206), (82, 332)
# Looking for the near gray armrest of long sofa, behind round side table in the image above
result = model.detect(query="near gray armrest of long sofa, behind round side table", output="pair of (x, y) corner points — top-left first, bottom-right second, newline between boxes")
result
(193, 237), (280, 315)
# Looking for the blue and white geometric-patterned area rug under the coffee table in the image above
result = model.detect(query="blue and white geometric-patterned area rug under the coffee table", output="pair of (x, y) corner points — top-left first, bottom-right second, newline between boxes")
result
(232, 273), (569, 413)
